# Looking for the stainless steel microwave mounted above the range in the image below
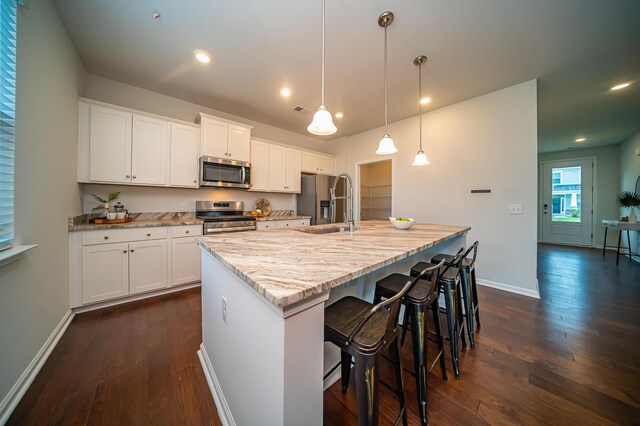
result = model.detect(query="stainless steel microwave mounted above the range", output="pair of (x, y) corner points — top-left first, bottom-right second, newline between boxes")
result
(200, 156), (251, 189)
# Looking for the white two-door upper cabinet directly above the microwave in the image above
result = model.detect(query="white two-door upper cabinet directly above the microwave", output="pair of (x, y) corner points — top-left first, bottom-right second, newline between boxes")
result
(196, 113), (251, 161)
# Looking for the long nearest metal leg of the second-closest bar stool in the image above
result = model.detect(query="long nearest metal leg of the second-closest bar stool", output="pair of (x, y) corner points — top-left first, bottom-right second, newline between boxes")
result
(411, 305), (427, 426)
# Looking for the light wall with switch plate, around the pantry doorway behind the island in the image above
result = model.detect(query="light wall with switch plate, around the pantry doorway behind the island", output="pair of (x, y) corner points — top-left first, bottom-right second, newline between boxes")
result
(338, 80), (538, 296)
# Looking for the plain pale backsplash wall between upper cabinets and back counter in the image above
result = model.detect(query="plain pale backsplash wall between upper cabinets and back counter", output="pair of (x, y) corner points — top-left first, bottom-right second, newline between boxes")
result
(79, 184), (296, 214)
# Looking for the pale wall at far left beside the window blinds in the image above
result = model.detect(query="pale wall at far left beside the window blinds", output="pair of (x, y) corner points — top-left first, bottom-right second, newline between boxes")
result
(0, 1), (85, 414)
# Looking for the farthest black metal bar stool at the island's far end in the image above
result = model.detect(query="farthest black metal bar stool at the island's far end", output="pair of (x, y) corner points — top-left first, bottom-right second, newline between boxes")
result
(431, 241), (480, 348)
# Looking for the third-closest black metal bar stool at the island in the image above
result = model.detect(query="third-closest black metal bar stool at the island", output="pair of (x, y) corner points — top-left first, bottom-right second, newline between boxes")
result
(411, 248), (467, 379)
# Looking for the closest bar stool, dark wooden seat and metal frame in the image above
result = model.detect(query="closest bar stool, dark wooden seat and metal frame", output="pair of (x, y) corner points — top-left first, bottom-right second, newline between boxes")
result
(324, 264), (436, 426)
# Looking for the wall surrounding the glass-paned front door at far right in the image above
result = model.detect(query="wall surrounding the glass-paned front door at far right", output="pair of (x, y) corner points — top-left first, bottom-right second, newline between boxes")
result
(538, 145), (620, 248)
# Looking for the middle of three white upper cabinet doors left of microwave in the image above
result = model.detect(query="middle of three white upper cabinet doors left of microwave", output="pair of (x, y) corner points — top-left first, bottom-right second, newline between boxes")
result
(131, 115), (168, 185)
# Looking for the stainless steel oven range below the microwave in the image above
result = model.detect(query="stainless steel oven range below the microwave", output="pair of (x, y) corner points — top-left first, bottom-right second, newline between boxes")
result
(196, 201), (256, 235)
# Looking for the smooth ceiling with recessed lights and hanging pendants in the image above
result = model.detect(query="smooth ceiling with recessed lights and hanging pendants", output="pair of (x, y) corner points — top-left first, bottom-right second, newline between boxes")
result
(53, 0), (640, 152)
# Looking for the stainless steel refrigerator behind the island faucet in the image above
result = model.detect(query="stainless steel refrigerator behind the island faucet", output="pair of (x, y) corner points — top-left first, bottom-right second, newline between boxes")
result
(298, 175), (345, 225)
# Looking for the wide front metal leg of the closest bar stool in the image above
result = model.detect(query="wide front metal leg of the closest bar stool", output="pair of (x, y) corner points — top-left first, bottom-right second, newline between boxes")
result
(356, 354), (379, 426)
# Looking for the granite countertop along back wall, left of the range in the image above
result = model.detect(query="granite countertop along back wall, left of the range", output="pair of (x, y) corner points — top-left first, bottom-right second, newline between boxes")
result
(69, 212), (203, 232)
